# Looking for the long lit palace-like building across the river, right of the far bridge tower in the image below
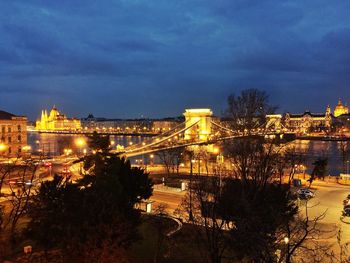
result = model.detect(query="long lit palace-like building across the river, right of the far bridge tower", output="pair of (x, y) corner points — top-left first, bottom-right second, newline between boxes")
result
(283, 106), (332, 133)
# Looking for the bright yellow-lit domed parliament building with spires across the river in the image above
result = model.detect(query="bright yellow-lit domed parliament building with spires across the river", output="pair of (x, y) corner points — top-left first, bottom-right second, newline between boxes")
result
(36, 106), (81, 131)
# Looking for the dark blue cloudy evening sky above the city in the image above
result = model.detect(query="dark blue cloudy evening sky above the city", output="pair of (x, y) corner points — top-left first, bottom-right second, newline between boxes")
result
(0, 0), (350, 119)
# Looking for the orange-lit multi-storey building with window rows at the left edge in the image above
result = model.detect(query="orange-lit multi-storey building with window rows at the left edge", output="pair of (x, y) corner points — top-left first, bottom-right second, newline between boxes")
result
(0, 111), (30, 157)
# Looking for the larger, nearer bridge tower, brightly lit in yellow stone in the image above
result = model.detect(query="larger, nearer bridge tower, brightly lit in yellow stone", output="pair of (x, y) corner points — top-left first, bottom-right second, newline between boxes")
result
(183, 109), (213, 141)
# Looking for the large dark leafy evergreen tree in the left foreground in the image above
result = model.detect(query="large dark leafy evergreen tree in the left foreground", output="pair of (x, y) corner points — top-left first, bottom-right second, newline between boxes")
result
(28, 136), (152, 262)
